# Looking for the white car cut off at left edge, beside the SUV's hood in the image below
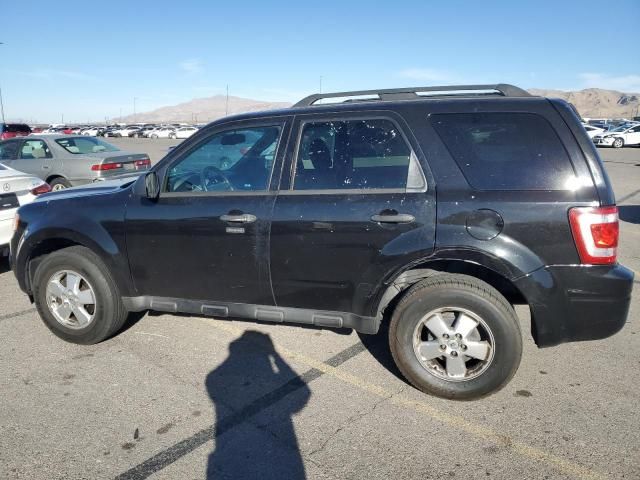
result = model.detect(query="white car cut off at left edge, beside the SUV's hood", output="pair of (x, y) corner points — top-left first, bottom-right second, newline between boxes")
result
(0, 163), (51, 256)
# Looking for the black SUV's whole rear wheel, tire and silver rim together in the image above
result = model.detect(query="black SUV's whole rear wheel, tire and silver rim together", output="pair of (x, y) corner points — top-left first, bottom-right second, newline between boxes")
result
(389, 274), (522, 400)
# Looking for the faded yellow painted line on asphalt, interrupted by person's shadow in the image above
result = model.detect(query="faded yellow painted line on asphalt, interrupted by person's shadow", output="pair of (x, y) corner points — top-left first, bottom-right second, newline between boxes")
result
(205, 320), (606, 480)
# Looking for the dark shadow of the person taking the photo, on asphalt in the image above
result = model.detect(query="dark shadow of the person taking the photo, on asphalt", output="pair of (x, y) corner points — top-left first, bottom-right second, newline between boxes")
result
(205, 330), (311, 480)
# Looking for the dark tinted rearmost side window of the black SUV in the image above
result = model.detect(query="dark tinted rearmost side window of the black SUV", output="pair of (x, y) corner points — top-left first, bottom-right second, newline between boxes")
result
(431, 113), (575, 190)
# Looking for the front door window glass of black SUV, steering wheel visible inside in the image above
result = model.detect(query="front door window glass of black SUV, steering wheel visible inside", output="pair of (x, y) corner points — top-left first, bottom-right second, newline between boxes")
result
(165, 126), (281, 192)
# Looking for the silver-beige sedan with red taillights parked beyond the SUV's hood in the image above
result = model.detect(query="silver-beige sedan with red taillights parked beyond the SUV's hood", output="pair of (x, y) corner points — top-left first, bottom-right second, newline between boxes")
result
(0, 135), (151, 191)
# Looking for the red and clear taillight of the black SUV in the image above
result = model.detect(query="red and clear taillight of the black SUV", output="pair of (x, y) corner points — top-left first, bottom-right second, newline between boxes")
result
(569, 206), (619, 264)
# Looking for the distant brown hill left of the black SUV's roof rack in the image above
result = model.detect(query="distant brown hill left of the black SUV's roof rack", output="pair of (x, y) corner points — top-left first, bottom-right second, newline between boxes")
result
(113, 95), (291, 123)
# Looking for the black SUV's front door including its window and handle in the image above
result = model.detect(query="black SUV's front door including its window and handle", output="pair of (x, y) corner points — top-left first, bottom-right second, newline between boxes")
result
(126, 117), (291, 305)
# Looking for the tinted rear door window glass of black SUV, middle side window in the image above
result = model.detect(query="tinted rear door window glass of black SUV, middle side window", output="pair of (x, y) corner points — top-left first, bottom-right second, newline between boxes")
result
(293, 119), (411, 190)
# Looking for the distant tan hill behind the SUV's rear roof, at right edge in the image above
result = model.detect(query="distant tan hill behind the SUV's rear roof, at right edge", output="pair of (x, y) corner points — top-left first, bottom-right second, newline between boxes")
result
(529, 88), (640, 119)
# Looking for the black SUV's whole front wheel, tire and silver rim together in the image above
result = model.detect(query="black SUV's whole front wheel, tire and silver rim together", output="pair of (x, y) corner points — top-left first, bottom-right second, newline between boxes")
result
(33, 246), (128, 345)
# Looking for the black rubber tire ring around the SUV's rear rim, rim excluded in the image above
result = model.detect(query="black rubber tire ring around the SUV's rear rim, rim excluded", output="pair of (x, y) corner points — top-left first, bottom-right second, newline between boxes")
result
(389, 288), (522, 400)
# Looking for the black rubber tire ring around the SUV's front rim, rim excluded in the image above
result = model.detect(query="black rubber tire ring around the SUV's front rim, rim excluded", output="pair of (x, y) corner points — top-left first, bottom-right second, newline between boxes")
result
(33, 252), (118, 344)
